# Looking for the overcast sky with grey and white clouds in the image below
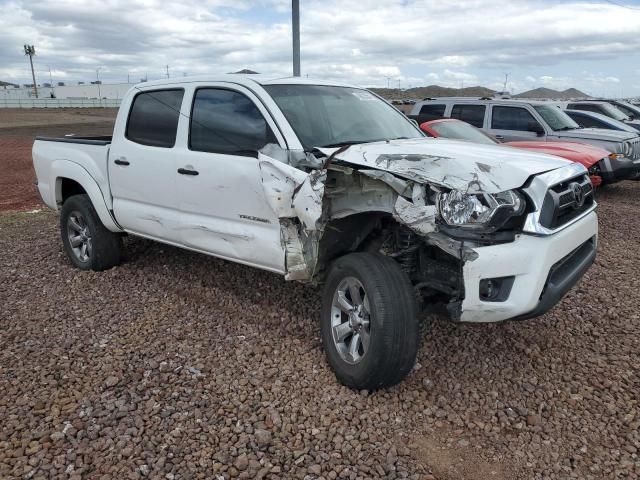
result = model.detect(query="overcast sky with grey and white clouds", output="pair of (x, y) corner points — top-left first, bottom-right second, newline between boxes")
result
(0, 0), (640, 96)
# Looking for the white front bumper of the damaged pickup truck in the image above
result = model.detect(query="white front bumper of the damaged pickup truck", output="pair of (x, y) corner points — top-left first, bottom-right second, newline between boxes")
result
(459, 212), (598, 322)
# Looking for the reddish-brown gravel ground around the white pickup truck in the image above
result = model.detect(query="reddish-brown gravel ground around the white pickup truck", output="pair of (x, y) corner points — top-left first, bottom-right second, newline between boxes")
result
(0, 109), (640, 480)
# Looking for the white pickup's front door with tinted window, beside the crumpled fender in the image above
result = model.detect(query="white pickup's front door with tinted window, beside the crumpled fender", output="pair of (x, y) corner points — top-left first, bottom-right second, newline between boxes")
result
(177, 84), (286, 273)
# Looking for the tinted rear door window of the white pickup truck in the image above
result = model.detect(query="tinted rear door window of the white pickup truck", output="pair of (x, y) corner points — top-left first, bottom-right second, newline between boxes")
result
(125, 89), (184, 148)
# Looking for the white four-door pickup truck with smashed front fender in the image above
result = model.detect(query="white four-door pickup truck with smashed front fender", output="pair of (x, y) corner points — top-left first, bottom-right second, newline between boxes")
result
(33, 75), (597, 389)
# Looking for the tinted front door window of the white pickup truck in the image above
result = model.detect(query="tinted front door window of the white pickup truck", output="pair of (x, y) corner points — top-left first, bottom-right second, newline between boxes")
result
(189, 88), (277, 154)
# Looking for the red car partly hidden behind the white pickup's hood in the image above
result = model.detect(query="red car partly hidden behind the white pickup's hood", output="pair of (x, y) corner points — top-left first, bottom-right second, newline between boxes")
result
(420, 118), (609, 187)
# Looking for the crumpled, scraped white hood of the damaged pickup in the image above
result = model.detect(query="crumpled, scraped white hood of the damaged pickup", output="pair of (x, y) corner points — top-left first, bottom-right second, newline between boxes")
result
(319, 138), (570, 193)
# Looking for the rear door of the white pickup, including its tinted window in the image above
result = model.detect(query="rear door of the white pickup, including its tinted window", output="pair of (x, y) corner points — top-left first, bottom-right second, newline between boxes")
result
(108, 88), (184, 243)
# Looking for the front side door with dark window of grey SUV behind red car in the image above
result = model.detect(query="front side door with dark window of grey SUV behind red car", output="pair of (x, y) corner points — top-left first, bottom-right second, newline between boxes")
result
(488, 105), (545, 142)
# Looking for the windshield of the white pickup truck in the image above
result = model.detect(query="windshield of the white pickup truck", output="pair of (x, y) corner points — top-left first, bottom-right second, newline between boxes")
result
(264, 85), (424, 150)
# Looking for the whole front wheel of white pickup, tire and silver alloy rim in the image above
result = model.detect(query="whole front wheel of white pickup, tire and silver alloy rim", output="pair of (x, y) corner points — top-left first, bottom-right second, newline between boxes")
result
(321, 253), (419, 390)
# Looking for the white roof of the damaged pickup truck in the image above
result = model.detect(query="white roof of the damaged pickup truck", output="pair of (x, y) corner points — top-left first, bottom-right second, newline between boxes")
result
(136, 73), (362, 89)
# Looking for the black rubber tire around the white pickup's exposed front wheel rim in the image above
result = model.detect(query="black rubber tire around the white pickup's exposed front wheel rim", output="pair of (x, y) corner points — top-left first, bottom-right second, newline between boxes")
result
(321, 252), (419, 390)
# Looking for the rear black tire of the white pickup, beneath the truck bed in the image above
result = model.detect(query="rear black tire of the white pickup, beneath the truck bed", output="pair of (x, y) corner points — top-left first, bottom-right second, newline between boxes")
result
(60, 194), (122, 271)
